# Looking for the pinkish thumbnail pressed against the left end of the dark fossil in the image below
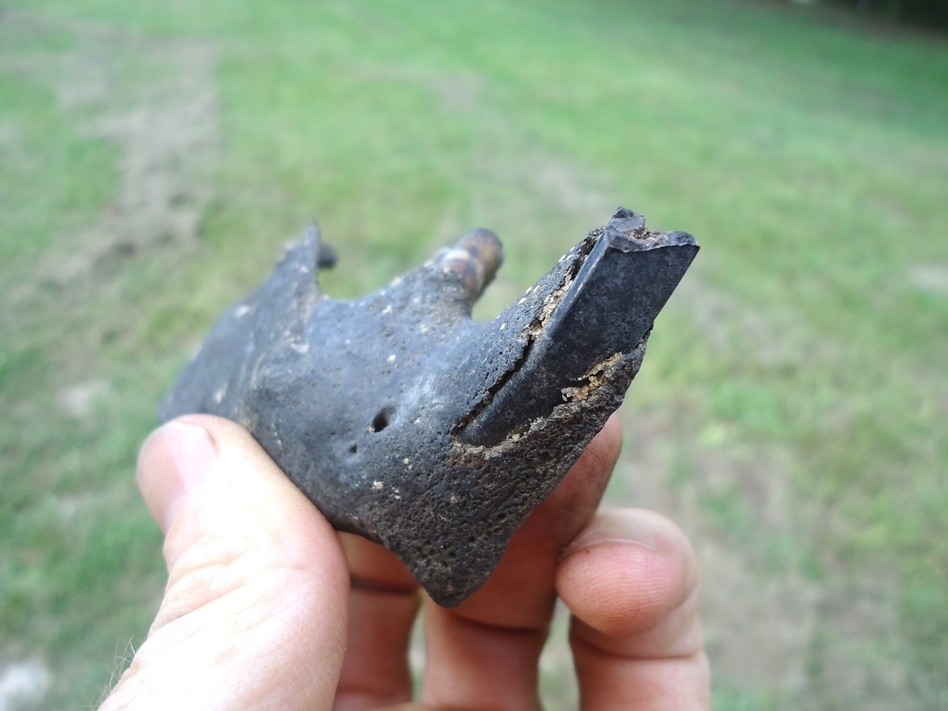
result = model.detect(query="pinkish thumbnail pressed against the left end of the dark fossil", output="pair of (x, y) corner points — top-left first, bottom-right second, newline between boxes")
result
(138, 420), (219, 532)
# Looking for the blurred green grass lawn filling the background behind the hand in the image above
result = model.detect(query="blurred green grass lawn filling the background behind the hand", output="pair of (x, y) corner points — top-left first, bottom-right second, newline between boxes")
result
(0, 0), (948, 708)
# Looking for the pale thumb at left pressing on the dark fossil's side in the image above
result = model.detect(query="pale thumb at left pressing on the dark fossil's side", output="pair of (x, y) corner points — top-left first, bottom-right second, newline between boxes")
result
(102, 416), (349, 710)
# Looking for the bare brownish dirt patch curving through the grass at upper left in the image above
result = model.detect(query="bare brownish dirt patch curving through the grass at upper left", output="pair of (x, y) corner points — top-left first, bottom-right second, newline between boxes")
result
(0, 12), (220, 287)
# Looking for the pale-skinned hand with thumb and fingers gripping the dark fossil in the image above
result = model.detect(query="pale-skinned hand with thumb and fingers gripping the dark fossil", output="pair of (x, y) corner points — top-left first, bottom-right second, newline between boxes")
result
(101, 416), (710, 711)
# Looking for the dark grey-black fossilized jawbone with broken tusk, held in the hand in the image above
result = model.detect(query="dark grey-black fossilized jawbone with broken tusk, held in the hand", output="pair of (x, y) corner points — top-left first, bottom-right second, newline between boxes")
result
(160, 209), (698, 606)
